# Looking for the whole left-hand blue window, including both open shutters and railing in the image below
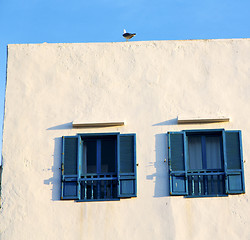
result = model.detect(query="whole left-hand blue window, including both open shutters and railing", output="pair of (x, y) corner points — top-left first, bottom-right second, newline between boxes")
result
(61, 133), (136, 201)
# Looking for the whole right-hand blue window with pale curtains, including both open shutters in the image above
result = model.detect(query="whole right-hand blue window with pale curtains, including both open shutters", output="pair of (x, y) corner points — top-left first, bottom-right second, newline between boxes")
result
(168, 129), (245, 197)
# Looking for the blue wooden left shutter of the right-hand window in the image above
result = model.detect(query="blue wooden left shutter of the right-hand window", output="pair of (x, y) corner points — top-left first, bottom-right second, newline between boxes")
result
(168, 132), (188, 195)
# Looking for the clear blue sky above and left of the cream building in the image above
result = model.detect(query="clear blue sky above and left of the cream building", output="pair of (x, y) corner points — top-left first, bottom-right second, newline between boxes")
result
(0, 0), (250, 163)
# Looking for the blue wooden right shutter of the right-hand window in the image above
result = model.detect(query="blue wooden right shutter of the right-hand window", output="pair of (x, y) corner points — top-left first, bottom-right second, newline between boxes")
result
(223, 131), (245, 194)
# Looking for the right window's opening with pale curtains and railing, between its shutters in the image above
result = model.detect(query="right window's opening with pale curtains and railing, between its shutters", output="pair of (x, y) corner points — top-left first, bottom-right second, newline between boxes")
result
(187, 133), (225, 196)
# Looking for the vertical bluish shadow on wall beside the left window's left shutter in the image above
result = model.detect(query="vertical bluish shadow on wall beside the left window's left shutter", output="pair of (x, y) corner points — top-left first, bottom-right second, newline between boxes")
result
(44, 137), (62, 201)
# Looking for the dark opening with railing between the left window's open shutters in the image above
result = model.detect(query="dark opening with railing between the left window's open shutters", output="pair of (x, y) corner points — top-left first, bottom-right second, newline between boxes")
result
(81, 136), (118, 199)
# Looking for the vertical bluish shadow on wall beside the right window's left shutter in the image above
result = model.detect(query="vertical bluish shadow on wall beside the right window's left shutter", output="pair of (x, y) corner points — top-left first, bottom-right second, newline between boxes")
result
(147, 133), (169, 197)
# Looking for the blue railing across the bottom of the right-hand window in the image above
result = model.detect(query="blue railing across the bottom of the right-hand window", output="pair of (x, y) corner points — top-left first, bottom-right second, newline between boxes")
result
(187, 170), (225, 196)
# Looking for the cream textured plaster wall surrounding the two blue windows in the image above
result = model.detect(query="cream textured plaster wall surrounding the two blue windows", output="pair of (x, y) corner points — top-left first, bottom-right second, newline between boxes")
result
(0, 39), (250, 240)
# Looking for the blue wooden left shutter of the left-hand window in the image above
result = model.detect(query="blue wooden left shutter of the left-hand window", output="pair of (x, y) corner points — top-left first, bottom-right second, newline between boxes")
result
(61, 136), (79, 199)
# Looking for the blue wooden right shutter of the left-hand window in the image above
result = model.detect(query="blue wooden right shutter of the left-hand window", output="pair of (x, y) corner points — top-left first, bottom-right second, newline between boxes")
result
(117, 134), (137, 197)
